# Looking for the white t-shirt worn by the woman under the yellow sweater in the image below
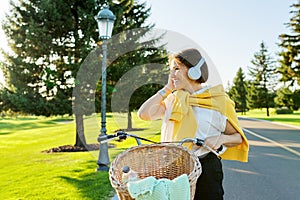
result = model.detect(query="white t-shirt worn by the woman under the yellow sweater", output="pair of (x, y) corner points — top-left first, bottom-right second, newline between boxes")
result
(161, 87), (227, 156)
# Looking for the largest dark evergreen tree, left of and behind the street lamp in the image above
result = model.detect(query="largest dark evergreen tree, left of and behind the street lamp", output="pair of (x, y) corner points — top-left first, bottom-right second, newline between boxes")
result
(1, 0), (168, 146)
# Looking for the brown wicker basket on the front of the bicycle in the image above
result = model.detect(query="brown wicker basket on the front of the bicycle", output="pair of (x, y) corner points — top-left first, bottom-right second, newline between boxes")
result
(109, 144), (201, 200)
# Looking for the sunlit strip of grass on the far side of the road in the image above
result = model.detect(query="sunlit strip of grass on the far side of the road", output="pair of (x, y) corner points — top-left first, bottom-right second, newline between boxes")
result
(238, 109), (300, 126)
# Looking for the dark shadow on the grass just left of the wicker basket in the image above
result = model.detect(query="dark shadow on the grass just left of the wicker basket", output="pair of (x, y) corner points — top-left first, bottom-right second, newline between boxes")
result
(60, 161), (113, 200)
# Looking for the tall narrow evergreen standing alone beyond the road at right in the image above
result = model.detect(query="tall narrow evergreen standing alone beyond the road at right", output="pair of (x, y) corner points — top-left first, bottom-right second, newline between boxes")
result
(248, 42), (275, 116)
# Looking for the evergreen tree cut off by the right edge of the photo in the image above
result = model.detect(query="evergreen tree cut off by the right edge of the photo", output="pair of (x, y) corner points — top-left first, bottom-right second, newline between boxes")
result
(278, 0), (300, 86)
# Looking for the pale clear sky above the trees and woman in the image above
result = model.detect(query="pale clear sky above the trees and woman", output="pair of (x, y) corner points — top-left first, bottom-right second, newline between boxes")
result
(0, 0), (297, 86)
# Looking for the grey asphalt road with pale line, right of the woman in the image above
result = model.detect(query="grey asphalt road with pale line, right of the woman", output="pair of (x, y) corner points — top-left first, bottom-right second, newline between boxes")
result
(112, 118), (300, 200)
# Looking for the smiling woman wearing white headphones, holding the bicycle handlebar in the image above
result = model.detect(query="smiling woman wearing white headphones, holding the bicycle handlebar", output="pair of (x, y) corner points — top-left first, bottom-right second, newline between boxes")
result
(138, 49), (248, 200)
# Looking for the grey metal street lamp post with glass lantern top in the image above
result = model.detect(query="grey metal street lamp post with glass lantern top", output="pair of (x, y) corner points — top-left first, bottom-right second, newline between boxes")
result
(95, 5), (116, 171)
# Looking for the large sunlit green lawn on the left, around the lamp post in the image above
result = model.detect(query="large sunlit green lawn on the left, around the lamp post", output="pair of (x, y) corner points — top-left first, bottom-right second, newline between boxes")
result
(0, 114), (160, 200)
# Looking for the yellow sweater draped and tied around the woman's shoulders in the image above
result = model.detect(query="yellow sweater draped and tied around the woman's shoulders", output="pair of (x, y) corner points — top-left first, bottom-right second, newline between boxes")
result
(170, 85), (249, 162)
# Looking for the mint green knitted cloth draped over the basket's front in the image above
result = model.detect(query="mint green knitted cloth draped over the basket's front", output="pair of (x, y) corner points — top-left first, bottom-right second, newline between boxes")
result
(127, 174), (190, 200)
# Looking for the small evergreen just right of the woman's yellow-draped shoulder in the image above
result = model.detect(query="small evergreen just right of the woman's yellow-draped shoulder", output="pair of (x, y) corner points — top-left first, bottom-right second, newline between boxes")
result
(228, 67), (247, 114)
